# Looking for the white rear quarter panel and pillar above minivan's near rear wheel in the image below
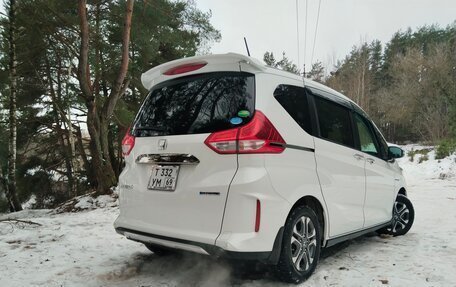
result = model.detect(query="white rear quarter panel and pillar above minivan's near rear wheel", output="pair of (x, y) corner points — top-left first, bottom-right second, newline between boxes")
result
(256, 72), (329, 241)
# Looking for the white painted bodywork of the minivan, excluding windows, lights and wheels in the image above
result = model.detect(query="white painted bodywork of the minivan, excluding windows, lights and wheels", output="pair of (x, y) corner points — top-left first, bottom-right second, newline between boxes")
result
(115, 54), (404, 255)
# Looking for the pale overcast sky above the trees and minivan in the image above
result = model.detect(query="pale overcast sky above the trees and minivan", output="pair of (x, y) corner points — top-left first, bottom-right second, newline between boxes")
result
(196, 0), (456, 71)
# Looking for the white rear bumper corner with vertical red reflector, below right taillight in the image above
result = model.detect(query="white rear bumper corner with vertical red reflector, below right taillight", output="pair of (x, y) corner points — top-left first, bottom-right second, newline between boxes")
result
(216, 154), (291, 252)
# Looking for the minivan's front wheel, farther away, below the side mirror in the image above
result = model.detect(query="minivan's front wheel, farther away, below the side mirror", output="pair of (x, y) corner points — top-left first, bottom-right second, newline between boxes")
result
(378, 194), (415, 236)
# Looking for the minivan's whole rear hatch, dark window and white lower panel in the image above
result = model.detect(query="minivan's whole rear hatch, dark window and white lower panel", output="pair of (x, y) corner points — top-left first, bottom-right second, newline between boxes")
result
(120, 72), (255, 244)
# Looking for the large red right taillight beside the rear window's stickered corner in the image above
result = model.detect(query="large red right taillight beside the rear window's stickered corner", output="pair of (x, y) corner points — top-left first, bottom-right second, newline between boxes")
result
(204, 111), (285, 154)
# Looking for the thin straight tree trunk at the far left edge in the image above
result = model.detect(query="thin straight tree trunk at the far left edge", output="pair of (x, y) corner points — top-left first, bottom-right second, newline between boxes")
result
(6, 0), (22, 211)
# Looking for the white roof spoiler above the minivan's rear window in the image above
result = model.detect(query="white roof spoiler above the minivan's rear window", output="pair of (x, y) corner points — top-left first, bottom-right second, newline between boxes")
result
(141, 53), (267, 90)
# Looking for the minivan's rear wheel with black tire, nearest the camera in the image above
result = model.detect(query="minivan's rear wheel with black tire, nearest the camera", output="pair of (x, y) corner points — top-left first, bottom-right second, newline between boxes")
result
(276, 206), (321, 284)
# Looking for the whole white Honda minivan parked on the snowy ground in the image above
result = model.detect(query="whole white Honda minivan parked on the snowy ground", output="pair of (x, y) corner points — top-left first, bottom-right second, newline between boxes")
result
(114, 53), (414, 283)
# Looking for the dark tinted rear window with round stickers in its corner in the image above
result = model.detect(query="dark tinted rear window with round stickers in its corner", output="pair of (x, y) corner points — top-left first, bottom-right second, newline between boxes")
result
(132, 72), (255, 137)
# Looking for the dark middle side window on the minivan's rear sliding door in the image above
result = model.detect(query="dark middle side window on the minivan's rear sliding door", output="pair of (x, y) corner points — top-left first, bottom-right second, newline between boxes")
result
(315, 97), (355, 147)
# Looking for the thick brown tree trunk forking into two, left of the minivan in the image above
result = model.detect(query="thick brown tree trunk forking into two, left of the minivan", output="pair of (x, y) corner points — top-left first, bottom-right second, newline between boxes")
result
(78, 0), (134, 194)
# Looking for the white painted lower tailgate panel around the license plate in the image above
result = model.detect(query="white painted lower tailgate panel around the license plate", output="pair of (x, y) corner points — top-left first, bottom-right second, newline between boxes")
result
(116, 134), (237, 244)
